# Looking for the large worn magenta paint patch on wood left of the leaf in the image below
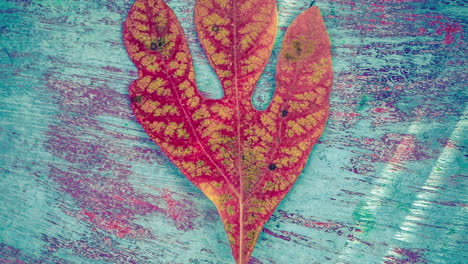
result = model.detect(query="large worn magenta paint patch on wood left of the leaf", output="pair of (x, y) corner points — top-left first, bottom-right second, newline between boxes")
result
(44, 72), (203, 263)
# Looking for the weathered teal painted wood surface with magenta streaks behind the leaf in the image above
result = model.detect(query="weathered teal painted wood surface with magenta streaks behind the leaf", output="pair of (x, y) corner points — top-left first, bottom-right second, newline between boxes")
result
(0, 0), (468, 264)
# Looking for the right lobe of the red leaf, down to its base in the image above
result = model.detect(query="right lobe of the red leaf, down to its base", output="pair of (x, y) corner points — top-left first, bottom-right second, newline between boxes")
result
(234, 7), (333, 263)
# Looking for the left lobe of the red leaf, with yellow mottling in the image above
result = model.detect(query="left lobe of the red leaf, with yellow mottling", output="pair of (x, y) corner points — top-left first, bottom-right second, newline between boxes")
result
(124, 0), (241, 205)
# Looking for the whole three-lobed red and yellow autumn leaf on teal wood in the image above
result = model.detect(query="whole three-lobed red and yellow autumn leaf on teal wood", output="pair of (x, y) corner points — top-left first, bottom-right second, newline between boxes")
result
(124, 0), (332, 264)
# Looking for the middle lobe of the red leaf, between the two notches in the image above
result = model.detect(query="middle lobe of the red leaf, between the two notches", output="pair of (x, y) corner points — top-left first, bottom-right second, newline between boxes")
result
(195, 0), (277, 101)
